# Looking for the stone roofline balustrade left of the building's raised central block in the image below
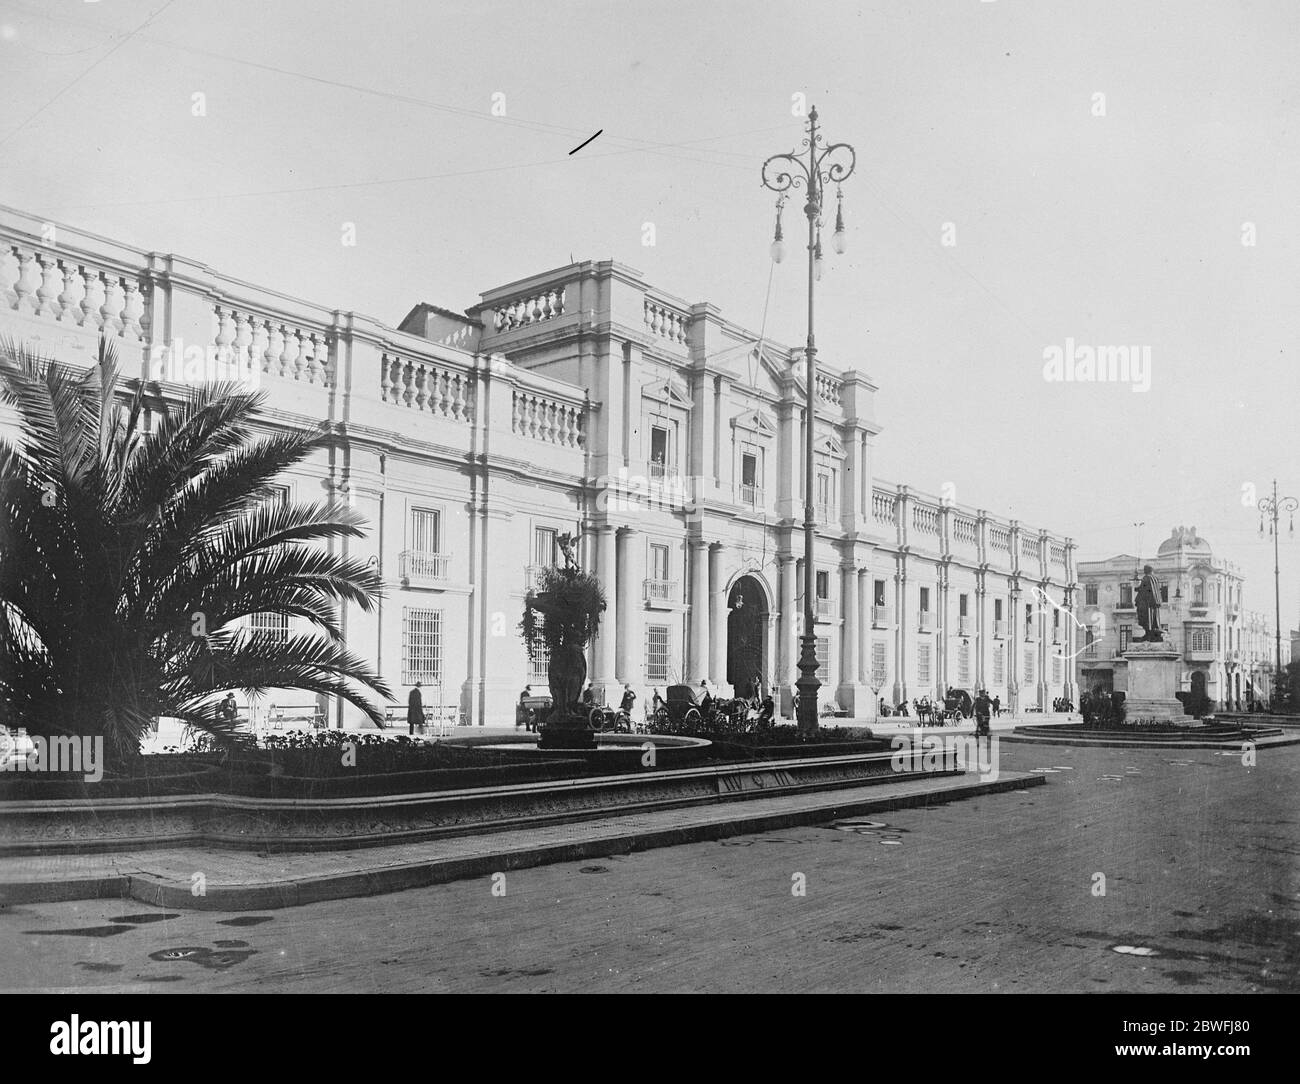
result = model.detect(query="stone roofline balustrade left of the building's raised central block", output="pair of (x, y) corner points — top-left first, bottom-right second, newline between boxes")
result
(0, 207), (592, 467)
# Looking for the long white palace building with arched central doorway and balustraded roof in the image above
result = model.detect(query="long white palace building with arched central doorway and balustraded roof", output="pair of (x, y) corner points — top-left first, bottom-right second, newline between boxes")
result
(0, 208), (1082, 725)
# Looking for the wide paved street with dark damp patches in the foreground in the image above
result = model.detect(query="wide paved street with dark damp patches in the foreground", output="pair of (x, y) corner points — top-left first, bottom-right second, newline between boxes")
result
(0, 743), (1300, 993)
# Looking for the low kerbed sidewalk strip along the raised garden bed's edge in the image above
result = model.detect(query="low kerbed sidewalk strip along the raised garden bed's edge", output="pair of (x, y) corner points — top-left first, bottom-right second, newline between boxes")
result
(0, 764), (1047, 911)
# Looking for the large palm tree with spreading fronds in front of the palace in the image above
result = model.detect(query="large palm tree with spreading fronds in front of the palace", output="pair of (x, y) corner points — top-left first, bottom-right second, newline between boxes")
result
(0, 341), (391, 759)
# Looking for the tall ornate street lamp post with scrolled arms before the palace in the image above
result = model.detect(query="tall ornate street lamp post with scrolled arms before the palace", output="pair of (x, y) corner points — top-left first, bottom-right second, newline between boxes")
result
(763, 107), (857, 733)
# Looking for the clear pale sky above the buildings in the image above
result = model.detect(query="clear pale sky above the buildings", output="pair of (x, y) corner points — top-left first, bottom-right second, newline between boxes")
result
(0, 0), (1300, 625)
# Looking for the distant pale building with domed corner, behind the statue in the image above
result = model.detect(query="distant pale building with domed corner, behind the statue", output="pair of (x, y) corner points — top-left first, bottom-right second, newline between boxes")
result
(1076, 526), (1273, 711)
